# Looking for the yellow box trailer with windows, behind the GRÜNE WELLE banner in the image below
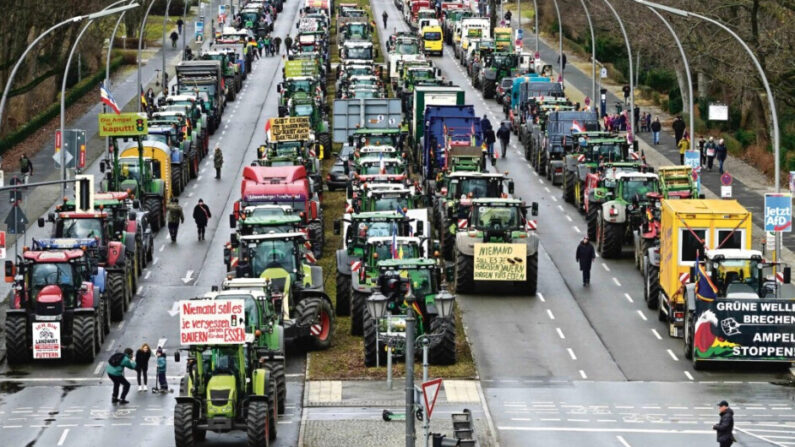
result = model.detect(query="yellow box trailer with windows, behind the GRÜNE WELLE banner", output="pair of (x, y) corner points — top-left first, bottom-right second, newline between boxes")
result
(645, 199), (751, 337)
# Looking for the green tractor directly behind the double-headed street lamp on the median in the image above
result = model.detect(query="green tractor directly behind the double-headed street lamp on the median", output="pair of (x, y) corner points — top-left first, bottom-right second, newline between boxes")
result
(363, 259), (456, 366)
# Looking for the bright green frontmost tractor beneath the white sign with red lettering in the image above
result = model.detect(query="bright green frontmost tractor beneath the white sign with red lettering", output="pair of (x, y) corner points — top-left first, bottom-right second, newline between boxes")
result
(174, 344), (278, 447)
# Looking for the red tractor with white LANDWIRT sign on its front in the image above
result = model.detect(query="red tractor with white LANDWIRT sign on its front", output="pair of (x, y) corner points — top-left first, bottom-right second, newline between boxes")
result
(5, 239), (110, 364)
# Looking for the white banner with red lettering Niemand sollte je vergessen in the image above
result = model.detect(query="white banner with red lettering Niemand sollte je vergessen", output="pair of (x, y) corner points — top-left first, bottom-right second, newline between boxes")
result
(179, 300), (246, 345)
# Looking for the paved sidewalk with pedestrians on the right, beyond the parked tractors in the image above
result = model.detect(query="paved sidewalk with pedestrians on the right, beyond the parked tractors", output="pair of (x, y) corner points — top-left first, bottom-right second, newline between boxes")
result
(524, 21), (795, 264)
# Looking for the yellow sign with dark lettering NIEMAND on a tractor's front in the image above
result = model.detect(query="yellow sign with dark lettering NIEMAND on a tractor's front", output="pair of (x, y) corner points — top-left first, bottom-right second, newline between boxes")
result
(474, 244), (527, 281)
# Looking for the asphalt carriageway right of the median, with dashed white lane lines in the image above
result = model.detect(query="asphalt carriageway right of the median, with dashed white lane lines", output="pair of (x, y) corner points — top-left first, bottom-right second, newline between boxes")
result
(366, 0), (795, 446)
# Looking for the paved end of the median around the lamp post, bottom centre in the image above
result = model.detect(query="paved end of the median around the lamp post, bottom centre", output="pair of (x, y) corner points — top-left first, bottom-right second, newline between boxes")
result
(298, 379), (496, 447)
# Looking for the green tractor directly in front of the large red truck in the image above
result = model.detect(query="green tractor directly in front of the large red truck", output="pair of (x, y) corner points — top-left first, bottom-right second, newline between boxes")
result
(224, 232), (334, 350)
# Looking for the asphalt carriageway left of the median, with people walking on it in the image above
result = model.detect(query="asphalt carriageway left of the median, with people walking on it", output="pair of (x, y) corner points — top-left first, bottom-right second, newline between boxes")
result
(0, 2), (305, 446)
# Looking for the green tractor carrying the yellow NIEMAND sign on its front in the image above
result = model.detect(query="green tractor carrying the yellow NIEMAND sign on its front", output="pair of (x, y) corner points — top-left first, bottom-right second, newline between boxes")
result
(455, 198), (540, 296)
